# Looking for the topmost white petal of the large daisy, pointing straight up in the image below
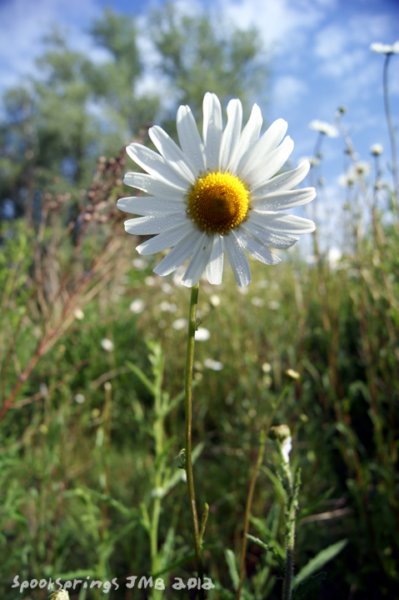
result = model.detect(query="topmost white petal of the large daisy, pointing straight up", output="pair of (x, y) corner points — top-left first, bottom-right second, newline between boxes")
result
(203, 92), (223, 170)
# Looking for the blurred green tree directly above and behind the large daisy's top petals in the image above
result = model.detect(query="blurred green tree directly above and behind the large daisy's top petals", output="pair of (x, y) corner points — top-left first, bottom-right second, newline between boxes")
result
(151, 2), (266, 114)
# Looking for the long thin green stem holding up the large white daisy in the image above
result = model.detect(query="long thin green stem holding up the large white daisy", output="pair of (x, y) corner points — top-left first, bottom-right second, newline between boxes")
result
(184, 284), (202, 571)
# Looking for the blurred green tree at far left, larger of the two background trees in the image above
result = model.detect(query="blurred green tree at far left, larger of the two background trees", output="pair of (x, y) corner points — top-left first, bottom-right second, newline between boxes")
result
(0, 11), (159, 212)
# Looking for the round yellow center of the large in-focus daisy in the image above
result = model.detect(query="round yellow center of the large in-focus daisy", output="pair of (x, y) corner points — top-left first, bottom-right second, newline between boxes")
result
(187, 172), (249, 234)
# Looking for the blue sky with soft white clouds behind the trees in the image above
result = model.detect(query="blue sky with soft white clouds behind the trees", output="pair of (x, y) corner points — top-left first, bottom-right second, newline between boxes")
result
(0, 0), (399, 244)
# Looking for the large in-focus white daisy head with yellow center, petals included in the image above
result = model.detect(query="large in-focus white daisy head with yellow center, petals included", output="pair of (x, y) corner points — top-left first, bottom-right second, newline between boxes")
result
(118, 93), (315, 287)
